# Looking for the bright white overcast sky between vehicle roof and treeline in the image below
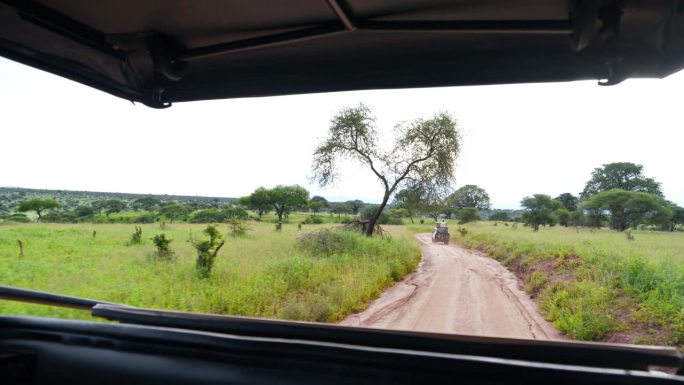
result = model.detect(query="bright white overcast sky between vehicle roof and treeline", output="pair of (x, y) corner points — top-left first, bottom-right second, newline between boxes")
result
(0, 59), (684, 208)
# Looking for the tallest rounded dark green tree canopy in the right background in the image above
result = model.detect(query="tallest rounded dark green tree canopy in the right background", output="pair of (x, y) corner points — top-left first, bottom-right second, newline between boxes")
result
(581, 162), (663, 199)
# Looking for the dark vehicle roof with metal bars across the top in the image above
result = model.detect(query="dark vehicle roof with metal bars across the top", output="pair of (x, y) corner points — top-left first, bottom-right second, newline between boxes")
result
(0, 0), (684, 108)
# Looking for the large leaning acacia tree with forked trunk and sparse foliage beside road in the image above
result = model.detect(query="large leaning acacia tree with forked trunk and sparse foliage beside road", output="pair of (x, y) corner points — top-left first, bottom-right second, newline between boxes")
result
(312, 104), (461, 236)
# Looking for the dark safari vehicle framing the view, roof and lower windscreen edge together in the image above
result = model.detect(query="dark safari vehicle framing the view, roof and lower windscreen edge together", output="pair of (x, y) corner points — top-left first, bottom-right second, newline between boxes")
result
(0, 0), (684, 385)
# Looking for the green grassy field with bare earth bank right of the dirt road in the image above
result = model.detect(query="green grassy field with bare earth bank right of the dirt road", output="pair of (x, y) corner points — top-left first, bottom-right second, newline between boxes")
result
(412, 222), (684, 347)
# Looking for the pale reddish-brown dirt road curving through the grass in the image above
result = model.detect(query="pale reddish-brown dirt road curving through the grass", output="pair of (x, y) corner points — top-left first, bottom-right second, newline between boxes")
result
(341, 234), (562, 339)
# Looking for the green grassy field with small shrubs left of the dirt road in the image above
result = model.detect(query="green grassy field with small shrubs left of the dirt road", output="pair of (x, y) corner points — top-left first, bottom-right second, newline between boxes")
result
(0, 218), (420, 322)
